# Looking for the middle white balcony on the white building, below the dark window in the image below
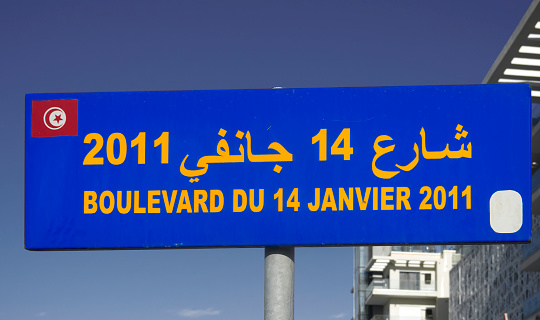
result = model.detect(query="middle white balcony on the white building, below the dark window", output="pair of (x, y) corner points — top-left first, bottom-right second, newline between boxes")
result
(366, 279), (437, 304)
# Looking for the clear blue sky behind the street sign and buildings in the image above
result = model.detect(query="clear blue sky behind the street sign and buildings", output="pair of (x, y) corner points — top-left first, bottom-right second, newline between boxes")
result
(0, 0), (531, 320)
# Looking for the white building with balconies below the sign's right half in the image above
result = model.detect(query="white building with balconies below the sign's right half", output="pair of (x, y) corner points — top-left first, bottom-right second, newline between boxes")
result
(354, 246), (459, 320)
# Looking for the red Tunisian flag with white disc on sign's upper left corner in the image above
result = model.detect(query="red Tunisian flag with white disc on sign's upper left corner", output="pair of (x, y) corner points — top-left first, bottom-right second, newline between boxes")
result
(32, 99), (78, 138)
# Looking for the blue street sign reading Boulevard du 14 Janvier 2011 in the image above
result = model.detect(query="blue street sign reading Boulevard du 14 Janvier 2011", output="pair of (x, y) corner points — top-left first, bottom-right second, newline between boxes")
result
(25, 84), (531, 250)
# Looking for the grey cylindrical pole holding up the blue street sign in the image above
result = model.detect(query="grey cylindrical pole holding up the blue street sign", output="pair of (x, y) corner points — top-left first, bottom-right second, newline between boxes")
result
(264, 247), (294, 320)
